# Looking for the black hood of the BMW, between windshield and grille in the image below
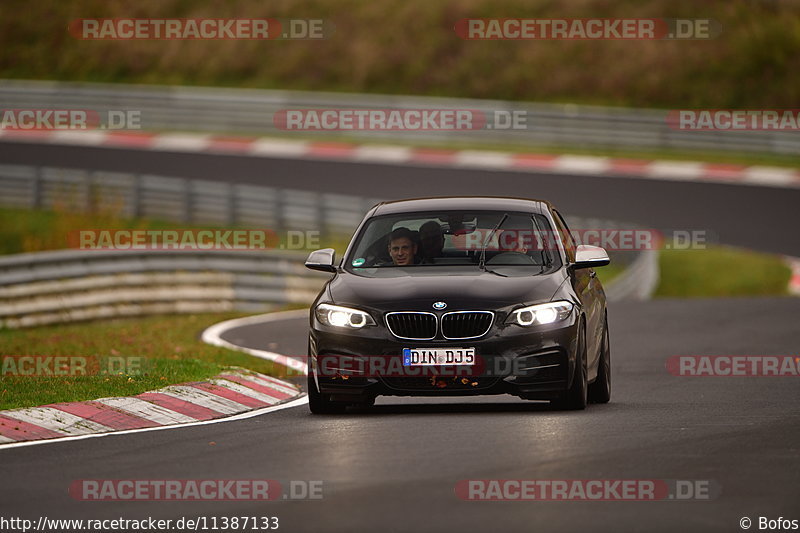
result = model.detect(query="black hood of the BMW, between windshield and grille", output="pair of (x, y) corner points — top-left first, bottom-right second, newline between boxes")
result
(328, 271), (564, 311)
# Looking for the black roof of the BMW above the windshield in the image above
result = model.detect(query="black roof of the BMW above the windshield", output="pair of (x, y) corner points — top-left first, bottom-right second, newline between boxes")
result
(372, 196), (552, 216)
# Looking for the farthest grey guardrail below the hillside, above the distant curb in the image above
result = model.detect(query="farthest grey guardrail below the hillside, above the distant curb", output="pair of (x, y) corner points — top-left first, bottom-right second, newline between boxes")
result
(0, 80), (800, 154)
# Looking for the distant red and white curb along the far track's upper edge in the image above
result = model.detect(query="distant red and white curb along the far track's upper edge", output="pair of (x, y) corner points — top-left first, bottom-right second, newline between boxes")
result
(0, 130), (800, 188)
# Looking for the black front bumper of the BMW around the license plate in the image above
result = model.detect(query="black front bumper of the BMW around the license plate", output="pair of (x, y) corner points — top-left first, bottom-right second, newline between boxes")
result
(309, 310), (579, 403)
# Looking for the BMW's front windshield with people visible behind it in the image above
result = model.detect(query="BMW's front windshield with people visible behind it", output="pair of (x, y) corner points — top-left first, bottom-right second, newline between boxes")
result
(344, 211), (561, 276)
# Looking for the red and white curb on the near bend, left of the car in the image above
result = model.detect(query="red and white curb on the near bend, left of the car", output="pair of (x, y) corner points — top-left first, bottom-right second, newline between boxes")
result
(0, 368), (306, 449)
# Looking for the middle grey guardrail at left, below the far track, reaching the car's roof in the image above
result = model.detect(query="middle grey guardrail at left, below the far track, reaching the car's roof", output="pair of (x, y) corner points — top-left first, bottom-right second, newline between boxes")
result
(0, 165), (379, 237)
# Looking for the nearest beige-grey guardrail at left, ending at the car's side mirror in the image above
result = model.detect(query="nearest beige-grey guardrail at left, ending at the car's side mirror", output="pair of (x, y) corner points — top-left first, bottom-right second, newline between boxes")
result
(0, 250), (328, 328)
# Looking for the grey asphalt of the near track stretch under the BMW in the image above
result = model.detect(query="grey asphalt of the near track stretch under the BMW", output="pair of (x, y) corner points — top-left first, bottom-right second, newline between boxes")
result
(0, 298), (800, 531)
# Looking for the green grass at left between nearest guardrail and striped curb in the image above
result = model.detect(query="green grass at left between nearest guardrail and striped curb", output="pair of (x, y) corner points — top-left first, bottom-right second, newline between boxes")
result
(0, 313), (298, 410)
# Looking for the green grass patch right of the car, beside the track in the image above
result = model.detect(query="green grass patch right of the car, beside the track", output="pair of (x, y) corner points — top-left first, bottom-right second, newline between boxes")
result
(655, 246), (791, 298)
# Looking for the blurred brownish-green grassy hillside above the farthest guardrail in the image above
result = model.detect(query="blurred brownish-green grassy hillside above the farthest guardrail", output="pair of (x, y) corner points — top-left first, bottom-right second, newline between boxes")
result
(0, 0), (800, 109)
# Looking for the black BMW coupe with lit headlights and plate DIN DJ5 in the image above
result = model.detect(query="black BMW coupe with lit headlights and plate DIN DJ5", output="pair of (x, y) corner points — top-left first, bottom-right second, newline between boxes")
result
(306, 197), (611, 413)
